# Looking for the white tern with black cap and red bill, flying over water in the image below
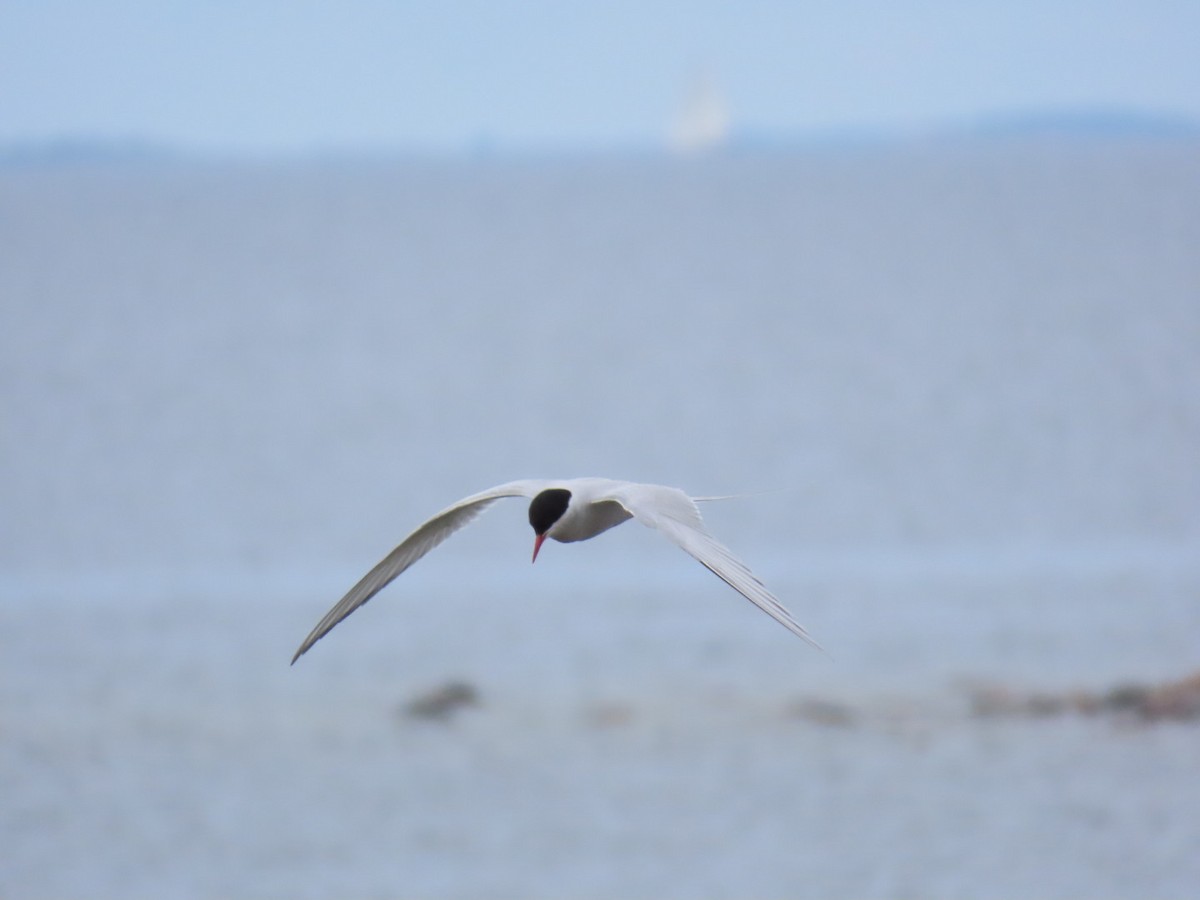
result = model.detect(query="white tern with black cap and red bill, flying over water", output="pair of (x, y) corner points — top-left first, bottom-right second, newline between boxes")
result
(292, 478), (820, 664)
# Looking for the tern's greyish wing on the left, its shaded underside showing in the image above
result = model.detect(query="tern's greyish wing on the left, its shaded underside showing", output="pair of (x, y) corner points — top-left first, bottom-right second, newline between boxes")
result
(292, 481), (545, 662)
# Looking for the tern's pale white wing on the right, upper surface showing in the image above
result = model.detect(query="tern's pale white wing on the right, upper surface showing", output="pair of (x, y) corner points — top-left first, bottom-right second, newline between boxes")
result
(607, 485), (822, 649)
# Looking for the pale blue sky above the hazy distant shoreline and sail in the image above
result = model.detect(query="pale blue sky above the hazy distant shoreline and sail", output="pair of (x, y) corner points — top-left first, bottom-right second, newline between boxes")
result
(7, 0), (1200, 155)
